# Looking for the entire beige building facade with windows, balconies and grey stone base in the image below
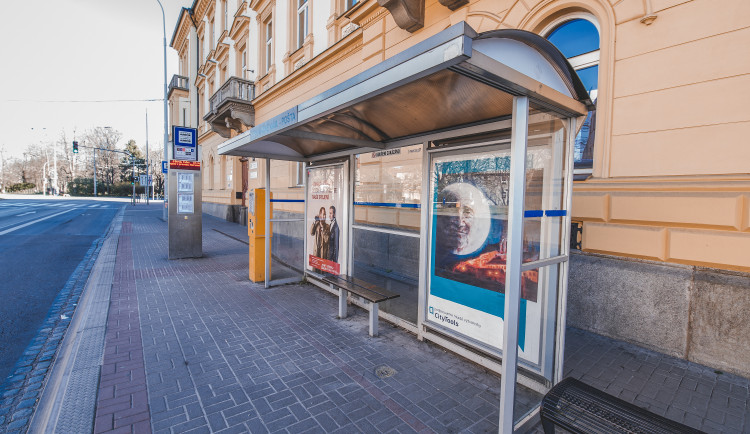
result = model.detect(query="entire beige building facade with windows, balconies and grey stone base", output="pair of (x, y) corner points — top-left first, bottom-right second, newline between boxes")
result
(170, 0), (750, 376)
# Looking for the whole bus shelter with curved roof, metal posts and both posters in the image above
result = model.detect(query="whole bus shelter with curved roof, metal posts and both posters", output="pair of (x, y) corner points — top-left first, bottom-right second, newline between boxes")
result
(219, 22), (593, 432)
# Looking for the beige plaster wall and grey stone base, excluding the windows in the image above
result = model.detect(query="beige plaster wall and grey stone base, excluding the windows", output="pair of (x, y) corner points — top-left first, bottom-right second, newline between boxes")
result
(172, 0), (750, 375)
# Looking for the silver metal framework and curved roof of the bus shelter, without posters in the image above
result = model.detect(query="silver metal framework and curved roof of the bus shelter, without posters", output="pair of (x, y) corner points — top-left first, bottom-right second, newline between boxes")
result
(219, 22), (593, 432)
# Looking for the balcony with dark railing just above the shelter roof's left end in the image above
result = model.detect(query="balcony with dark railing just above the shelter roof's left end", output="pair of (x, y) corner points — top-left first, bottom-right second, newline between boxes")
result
(203, 77), (255, 138)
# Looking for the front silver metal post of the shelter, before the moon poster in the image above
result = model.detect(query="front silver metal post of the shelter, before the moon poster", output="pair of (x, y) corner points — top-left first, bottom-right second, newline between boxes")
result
(499, 96), (529, 434)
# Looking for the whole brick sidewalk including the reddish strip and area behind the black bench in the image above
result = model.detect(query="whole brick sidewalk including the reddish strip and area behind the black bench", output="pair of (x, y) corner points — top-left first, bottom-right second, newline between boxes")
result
(13, 205), (750, 433)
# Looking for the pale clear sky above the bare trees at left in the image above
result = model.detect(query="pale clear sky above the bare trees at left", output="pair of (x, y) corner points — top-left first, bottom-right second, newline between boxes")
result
(0, 0), (193, 158)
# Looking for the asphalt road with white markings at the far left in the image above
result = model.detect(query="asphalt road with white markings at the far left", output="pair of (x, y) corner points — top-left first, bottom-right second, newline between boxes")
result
(0, 199), (119, 383)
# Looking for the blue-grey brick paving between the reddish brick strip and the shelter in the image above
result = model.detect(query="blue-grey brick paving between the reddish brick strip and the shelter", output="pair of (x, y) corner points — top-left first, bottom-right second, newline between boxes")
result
(126, 209), (539, 433)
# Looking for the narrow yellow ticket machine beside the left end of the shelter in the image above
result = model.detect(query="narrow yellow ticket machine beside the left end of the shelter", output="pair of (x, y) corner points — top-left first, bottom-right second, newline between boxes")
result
(247, 188), (273, 282)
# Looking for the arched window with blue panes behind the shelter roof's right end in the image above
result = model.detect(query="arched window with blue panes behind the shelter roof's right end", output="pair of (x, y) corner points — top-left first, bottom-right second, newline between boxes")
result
(542, 13), (600, 173)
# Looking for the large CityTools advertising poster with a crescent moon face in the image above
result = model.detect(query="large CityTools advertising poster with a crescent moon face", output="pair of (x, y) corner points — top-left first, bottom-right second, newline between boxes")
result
(427, 151), (542, 364)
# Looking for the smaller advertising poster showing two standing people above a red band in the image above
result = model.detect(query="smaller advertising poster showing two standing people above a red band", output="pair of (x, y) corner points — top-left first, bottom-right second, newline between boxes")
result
(305, 165), (346, 275)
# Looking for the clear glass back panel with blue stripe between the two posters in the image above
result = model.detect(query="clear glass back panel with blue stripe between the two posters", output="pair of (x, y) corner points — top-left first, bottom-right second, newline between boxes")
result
(352, 145), (422, 324)
